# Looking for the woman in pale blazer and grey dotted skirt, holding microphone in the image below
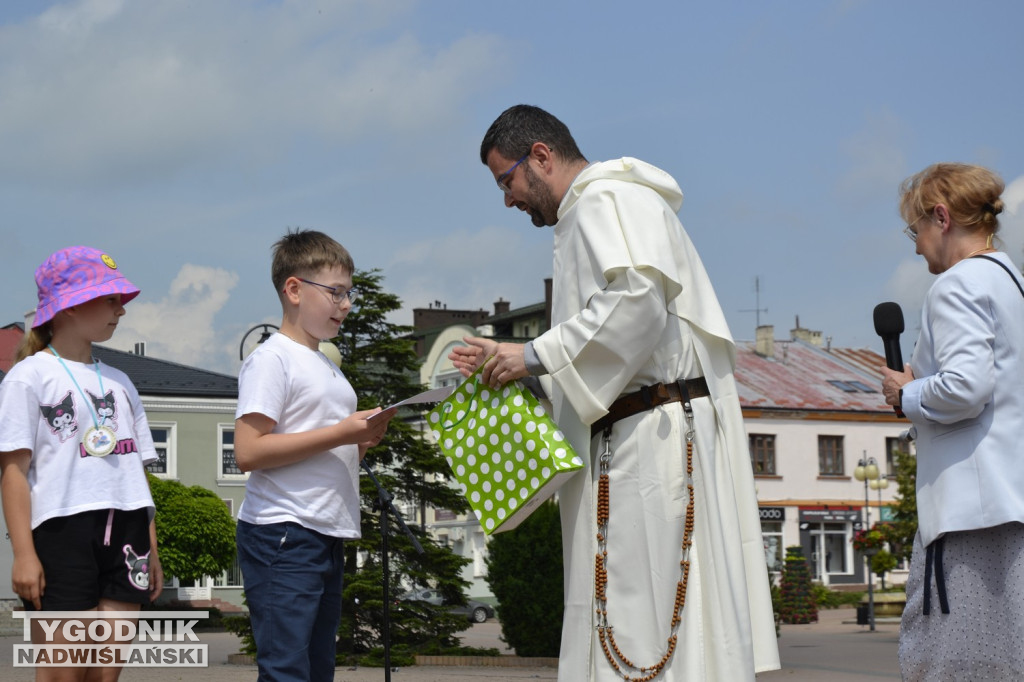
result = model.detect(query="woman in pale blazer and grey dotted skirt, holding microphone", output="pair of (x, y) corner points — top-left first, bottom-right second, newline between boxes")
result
(883, 164), (1024, 680)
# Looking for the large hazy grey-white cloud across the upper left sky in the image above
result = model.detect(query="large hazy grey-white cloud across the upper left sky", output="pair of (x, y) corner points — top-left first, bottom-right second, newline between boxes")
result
(0, 0), (502, 183)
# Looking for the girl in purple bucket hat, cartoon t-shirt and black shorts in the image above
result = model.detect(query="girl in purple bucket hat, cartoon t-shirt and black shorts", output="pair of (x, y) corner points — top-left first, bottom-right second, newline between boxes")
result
(0, 246), (164, 680)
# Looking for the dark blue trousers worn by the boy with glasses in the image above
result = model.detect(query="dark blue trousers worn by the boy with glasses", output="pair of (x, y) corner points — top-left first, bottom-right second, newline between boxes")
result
(236, 521), (344, 682)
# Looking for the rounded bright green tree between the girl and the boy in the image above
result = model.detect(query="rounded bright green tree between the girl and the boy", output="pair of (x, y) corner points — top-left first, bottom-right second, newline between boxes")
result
(146, 474), (234, 582)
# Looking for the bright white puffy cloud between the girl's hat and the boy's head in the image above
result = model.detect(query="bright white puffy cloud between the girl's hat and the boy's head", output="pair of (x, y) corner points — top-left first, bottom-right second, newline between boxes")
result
(108, 264), (239, 368)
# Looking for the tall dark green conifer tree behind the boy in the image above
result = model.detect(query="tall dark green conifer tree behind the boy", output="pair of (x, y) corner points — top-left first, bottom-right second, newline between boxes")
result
(334, 270), (469, 665)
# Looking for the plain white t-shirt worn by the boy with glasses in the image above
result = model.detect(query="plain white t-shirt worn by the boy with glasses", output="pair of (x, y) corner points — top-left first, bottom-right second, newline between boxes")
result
(234, 334), (360, 539)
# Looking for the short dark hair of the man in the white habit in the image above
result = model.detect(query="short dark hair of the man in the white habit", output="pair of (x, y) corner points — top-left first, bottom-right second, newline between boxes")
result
(480, 104), (587, 165)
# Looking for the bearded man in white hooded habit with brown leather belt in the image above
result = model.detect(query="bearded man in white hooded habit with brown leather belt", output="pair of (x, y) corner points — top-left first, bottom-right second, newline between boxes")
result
(450, 104), (779, 682)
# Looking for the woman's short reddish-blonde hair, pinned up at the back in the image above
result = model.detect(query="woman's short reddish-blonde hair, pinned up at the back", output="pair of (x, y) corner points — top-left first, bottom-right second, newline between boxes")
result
(899, 164), (1005, 235)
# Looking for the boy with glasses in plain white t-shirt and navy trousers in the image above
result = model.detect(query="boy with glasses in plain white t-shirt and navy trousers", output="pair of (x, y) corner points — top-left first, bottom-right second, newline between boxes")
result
(234, 230), (394, 682)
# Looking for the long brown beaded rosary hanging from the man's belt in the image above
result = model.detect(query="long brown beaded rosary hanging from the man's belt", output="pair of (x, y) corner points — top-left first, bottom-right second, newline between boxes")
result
(594, 402), (693, 682)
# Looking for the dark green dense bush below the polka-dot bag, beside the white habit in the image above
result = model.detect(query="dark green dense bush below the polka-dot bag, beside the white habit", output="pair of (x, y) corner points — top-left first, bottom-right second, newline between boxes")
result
(487, 500), (563, 656)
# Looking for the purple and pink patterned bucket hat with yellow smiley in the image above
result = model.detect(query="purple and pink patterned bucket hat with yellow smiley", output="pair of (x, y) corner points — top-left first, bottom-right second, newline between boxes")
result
(32, 247), (138, 328)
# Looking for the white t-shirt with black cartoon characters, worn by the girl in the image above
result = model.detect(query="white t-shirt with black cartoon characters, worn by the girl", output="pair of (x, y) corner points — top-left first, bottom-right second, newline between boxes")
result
(0, 351), (157, 528)
